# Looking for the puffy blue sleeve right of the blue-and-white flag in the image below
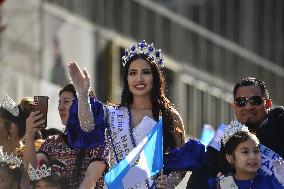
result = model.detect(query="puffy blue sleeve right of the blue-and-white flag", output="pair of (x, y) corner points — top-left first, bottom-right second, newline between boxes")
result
(163, 139), (205, 171)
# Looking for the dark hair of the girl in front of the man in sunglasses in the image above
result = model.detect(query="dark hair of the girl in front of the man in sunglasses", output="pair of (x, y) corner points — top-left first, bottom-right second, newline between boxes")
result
(220, 131), (259, 175)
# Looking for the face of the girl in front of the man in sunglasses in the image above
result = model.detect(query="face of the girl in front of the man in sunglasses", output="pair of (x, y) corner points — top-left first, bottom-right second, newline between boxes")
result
(227, 139), (261, 179)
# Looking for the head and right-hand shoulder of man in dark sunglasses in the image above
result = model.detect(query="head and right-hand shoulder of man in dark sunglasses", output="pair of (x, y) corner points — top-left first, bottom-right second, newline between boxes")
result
(233, 77), (284, 158)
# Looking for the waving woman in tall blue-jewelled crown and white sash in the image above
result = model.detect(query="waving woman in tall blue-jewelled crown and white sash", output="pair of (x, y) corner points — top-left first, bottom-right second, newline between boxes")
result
(67, 40), (184, 188)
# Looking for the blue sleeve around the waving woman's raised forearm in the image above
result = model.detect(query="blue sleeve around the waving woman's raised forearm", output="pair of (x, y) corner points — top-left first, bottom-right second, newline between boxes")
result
(66, 97), (106, 149)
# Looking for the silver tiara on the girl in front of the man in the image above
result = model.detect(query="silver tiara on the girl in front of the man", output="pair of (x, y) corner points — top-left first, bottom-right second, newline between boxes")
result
(221, 120), (249, 145)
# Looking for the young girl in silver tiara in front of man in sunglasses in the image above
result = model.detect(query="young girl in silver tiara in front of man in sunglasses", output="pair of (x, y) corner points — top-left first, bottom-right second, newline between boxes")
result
(206, 121), (284, 189)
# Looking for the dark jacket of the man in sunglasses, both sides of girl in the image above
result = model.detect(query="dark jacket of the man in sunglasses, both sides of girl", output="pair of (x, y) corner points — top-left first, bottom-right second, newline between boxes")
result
(186, 106), (284, 189)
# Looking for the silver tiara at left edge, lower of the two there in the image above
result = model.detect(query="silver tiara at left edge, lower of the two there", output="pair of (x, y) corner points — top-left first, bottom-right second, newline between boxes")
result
(0, 146), (22, 169)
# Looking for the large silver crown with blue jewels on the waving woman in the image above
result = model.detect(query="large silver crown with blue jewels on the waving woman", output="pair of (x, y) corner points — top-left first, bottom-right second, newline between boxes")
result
(122, 40), (164, 69)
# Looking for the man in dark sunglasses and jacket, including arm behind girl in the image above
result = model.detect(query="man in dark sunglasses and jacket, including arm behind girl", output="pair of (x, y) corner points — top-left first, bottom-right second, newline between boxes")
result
(187, 77), (284, 189)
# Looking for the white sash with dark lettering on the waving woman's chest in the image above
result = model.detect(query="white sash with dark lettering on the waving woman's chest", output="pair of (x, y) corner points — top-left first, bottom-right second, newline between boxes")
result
(108, 106), (134, 162)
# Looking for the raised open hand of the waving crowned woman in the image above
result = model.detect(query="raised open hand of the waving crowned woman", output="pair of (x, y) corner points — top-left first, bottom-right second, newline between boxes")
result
(68, 62), (90, 94)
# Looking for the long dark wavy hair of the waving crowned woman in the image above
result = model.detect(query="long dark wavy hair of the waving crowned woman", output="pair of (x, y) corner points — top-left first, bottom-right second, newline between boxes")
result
(120, 54), (179, 152)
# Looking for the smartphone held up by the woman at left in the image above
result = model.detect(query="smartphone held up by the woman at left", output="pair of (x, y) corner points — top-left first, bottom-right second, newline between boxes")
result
(33, 96), (49, 128)
